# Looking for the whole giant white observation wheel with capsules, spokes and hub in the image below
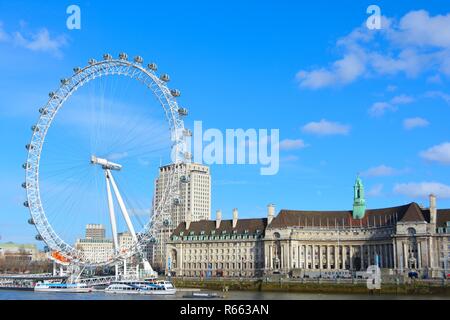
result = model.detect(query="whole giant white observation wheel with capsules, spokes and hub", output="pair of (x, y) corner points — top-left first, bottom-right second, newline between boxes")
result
(23, 53), (190, 266)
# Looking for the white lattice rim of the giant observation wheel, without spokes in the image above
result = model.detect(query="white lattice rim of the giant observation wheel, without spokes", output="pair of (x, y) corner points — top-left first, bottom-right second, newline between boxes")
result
(24, 54), (187, 266)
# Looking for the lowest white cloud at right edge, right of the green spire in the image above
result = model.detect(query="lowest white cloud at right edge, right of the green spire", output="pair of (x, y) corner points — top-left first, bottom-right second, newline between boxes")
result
(394, 182), (450, 198)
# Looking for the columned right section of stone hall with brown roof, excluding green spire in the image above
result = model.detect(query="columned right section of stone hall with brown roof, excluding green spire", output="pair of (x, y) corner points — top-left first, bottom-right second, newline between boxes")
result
(264, 196), (450, 277)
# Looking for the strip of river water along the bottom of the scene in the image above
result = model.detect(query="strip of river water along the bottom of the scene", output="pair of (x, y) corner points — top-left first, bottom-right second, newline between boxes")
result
(0, 290), (450, 300)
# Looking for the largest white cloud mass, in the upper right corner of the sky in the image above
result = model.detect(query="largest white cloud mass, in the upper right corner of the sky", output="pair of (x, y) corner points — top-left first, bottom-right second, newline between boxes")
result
(296, 10), (450, 89)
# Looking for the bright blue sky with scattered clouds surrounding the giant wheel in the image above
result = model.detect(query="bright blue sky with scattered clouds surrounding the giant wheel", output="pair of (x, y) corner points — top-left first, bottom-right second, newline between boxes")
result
(0, 0), (450, 242)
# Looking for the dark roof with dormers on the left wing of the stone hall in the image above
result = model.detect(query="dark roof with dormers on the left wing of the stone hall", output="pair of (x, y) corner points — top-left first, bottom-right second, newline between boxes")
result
(173, 218), (267, 236)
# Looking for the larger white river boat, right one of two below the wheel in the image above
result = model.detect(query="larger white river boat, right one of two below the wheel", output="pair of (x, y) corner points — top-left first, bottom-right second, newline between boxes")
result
(105, 280), (177, 295)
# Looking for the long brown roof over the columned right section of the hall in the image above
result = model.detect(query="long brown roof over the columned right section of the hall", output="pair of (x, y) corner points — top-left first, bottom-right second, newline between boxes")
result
(269, 202), (429, 228)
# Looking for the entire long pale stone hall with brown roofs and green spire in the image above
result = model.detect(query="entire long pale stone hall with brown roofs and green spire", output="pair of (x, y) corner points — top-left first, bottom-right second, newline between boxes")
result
(166, 177), (450, 277)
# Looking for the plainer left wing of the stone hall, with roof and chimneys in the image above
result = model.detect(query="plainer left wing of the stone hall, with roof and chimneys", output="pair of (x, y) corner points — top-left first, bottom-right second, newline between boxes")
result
(166, 209), (267, 277)
